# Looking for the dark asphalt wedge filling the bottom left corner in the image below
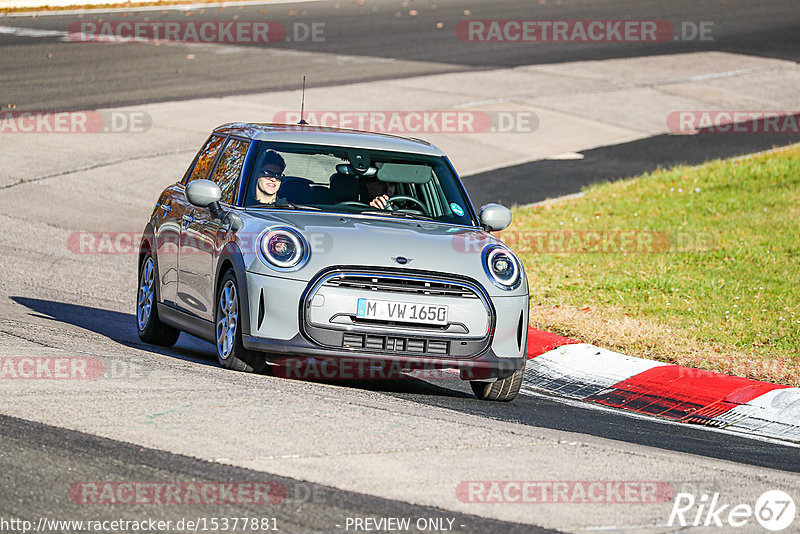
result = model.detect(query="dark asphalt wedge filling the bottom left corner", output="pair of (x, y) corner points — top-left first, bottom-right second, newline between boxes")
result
(0, 415), (555, 534)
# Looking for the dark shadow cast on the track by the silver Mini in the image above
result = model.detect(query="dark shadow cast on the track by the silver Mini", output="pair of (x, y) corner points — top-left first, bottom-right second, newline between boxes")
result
(9, 296), (466, 397)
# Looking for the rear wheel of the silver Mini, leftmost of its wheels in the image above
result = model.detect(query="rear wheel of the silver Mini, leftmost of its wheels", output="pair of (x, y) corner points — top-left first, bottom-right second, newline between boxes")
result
(136, 253), (181, 347)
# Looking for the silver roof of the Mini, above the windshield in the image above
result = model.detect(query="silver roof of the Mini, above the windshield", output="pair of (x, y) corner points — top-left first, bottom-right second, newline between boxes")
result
(214, 122), (444, 156)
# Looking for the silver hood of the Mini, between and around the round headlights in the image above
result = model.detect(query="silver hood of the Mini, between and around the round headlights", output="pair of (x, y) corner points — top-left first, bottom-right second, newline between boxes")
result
(238, 210), (527, 296)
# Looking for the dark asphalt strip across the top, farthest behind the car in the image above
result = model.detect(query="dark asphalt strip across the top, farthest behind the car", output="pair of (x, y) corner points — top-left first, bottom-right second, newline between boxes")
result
(0, 0), (800, 110)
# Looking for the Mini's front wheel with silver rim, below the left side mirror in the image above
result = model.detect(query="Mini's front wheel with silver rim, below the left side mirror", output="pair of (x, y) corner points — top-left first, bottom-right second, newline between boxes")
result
(214, 269), (267, 373)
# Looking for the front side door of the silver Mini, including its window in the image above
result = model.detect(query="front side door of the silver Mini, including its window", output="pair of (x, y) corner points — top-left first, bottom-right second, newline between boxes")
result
(178, 137), (249, 321)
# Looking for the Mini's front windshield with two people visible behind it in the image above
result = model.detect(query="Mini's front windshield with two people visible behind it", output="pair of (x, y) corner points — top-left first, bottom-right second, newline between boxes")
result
(244, 142), (475, 226)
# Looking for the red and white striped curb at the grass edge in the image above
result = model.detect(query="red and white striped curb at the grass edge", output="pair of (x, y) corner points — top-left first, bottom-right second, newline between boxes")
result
(523, 328), (800, 441)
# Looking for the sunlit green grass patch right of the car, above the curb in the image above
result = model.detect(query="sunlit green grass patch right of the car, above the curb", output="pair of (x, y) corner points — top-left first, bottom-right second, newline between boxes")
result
(505, 147), (800, 385)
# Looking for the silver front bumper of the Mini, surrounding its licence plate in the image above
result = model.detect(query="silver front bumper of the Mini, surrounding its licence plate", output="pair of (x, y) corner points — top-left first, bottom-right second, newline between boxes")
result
(243, 267), (528, 379)
